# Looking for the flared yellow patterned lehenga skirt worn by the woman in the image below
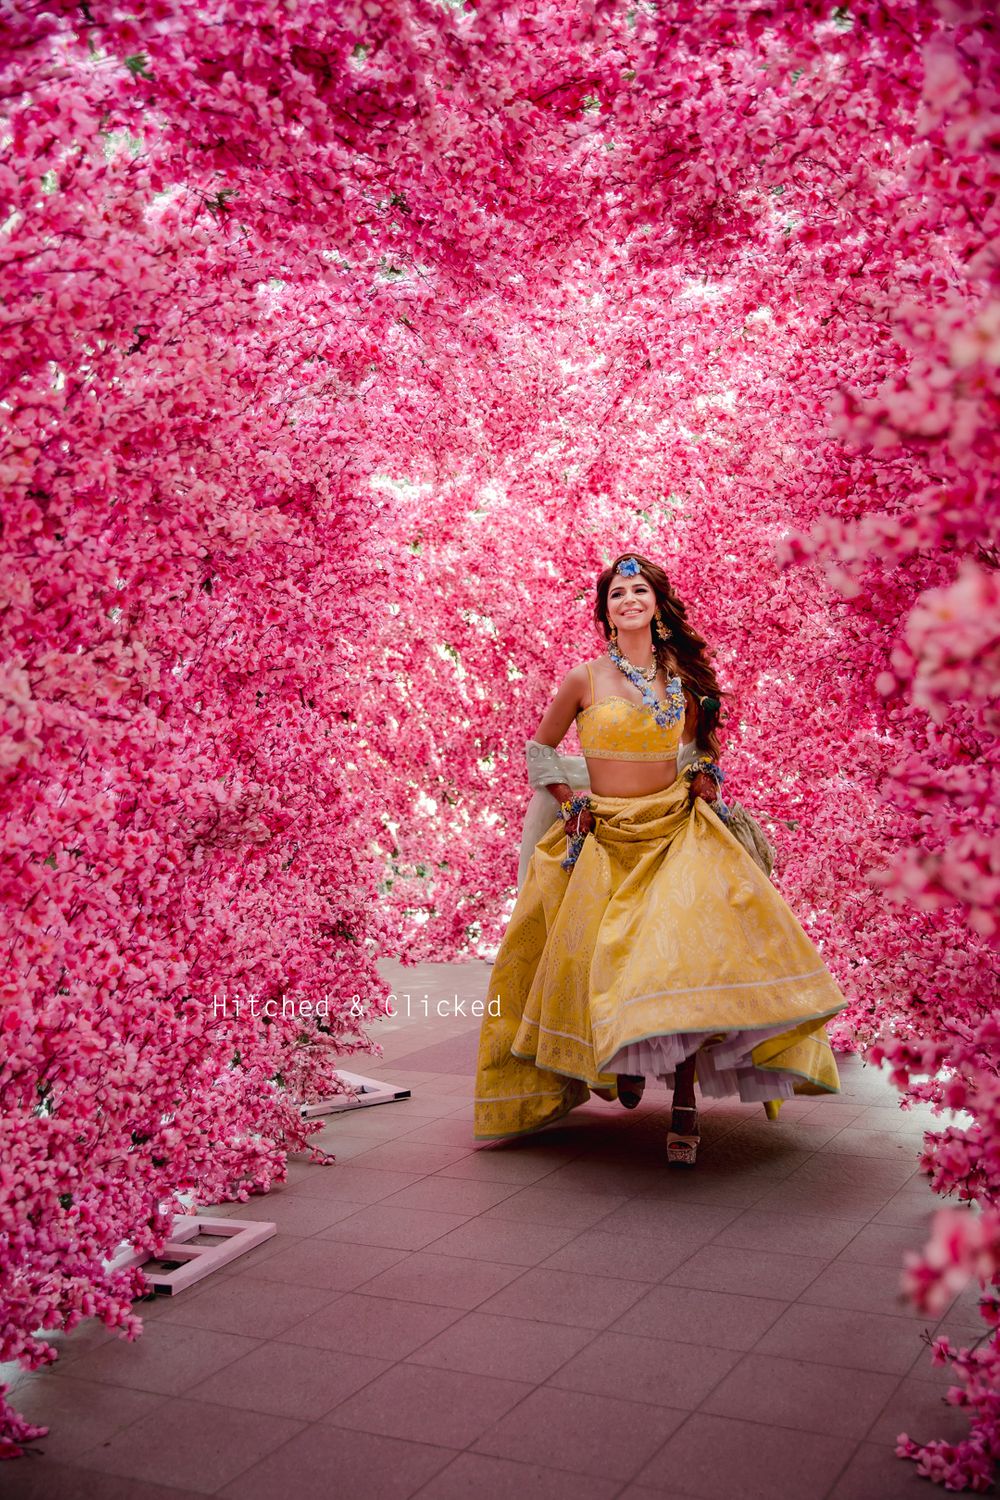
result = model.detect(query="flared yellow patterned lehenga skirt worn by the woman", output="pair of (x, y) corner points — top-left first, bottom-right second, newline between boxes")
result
(474, 777), (847, 1140)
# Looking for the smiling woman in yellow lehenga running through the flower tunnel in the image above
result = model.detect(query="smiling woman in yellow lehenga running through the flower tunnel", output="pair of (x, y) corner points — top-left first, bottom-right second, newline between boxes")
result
(475, 554), (846, 1166)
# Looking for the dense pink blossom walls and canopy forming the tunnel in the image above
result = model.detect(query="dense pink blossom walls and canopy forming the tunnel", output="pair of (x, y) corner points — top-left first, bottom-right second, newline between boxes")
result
(0, 0), (1000, 1490)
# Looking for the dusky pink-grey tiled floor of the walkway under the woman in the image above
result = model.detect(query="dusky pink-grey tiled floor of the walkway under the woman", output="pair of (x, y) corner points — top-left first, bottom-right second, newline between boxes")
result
(0, 965), (982, 1500)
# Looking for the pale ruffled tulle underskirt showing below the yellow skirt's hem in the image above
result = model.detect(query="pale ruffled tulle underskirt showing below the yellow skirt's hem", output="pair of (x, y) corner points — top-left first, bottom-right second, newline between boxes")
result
(601, 1022), (796, 1104)
